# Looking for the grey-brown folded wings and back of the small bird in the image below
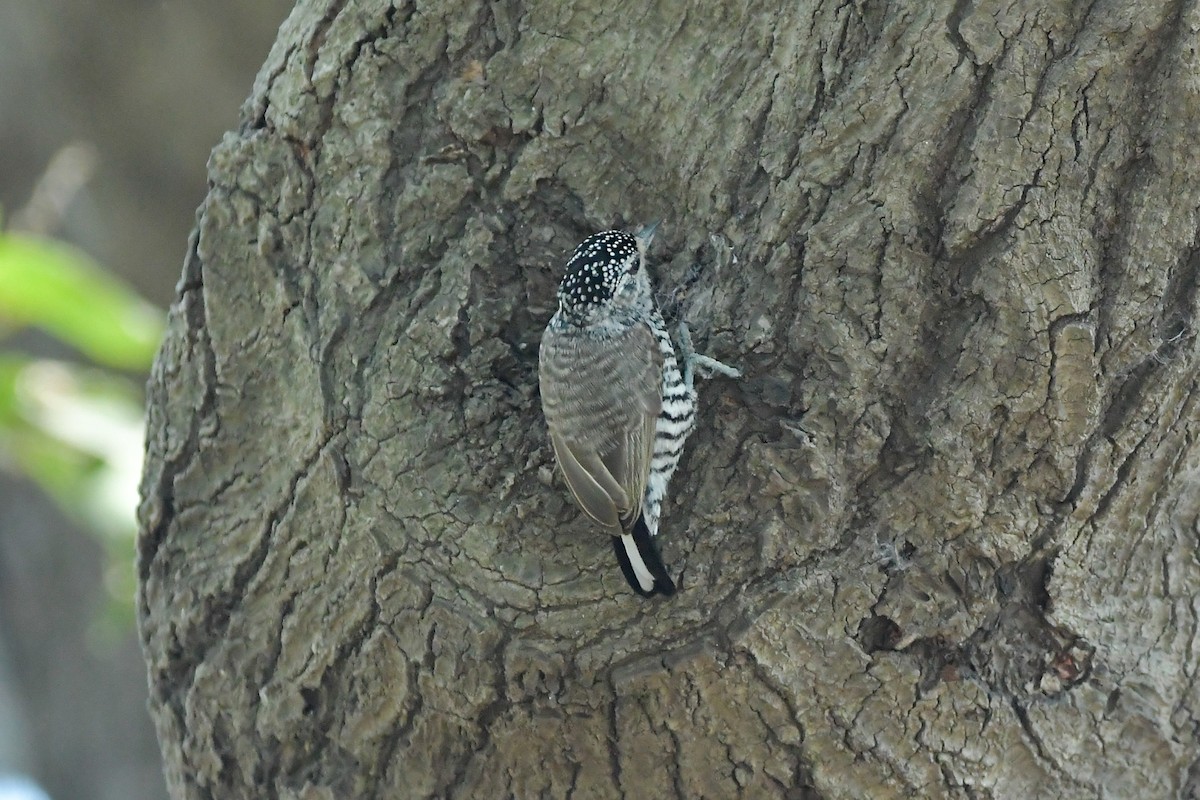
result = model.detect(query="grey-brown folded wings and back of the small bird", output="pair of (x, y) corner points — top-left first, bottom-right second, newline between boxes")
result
(539, 325), (662, 535)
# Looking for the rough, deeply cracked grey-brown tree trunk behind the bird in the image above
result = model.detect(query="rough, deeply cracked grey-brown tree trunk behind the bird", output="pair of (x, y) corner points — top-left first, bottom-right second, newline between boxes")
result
(139, 0), (1200, 799)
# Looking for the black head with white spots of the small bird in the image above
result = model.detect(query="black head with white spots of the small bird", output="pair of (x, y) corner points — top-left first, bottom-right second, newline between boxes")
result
(558, 230), (650, 324)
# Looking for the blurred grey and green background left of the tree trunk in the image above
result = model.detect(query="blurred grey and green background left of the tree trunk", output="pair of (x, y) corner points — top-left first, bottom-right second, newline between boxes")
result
(0, 0), (292, 800)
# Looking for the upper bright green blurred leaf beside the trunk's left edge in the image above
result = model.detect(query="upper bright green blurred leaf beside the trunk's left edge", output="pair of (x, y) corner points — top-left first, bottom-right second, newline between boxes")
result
(0, 233), (164, 369)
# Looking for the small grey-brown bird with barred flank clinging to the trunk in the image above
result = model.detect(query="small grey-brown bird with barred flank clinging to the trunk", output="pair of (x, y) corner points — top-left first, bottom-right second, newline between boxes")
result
(538, 223), (740, 597)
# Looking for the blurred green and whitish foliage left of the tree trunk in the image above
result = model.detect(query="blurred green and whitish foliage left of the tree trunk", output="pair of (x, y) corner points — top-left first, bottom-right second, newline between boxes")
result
(0, 225), (164, 628)
